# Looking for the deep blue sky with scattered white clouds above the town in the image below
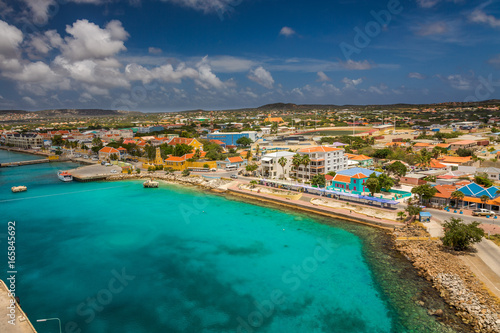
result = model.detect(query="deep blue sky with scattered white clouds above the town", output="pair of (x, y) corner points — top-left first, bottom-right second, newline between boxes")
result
(0, 0), (500, 111)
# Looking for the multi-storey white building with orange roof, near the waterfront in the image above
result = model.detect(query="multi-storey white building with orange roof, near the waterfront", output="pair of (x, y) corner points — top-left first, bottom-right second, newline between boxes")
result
(296, 146), (348, 179)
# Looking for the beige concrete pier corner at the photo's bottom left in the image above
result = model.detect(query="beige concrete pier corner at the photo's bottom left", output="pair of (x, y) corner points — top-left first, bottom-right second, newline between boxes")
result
(0, 280), (36, 333)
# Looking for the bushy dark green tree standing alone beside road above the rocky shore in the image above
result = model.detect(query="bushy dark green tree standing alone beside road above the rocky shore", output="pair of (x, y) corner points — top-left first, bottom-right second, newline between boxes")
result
(441, 217), (484, 251)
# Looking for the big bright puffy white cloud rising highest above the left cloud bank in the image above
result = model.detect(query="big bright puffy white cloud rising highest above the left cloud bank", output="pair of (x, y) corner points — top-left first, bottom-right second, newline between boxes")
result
(61, 20), (129, 61)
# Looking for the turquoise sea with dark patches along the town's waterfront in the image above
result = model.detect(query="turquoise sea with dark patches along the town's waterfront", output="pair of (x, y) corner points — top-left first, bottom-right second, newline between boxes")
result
(0, 151), (466, 333)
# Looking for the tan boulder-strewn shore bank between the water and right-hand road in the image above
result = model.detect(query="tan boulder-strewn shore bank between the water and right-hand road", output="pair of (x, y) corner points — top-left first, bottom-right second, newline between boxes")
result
(395, 227), (500, 333)
